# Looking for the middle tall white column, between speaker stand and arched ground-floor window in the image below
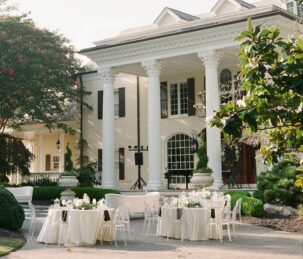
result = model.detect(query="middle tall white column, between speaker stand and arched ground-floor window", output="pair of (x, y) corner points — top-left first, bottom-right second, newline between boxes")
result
(142, 60), (164, 190)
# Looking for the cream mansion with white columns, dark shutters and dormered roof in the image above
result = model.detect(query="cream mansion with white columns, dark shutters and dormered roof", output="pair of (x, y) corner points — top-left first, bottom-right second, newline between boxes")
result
(16, 0), (301, 190)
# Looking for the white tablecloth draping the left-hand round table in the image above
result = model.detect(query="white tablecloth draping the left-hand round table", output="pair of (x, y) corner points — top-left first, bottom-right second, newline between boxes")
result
(37, 208), (114, 246)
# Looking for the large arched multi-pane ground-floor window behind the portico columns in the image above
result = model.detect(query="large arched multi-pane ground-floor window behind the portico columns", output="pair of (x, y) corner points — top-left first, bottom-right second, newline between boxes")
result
(167, 134), (194, 173)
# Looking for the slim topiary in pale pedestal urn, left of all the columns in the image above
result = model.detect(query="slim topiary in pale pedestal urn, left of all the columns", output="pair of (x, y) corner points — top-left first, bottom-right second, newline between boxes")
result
(59, 143), (79, 200)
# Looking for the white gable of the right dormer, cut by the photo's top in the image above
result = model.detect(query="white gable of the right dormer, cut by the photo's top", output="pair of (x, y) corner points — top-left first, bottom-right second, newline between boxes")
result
(211, 0), (255, 15)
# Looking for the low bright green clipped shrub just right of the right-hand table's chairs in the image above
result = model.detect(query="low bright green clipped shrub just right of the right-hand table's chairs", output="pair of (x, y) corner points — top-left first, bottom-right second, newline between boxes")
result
(225, 191), (264, 217)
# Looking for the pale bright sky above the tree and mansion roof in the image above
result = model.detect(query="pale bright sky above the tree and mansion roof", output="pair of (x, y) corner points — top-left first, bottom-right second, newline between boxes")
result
(8, 0), (217, 50)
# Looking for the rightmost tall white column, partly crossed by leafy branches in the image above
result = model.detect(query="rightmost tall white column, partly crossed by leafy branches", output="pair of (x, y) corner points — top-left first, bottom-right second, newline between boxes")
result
(198, 50), (223, 188)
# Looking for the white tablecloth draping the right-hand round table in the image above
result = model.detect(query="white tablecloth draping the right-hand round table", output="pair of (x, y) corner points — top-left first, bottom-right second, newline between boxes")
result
(157, 207), (218, 241)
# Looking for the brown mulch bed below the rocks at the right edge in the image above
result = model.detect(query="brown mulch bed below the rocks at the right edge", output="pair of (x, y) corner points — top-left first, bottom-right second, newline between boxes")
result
(242, 216), (303, 234)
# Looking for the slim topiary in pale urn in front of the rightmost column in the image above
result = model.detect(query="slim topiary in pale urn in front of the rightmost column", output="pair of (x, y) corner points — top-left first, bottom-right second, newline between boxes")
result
(191, 136), (214, 188)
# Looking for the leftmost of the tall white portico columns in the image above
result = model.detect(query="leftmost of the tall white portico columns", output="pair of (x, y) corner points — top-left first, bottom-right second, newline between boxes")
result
(99, 68), (116, 188)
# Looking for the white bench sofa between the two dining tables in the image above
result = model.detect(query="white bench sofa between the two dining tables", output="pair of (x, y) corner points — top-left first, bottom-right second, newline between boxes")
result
(105, 192), (160, 214)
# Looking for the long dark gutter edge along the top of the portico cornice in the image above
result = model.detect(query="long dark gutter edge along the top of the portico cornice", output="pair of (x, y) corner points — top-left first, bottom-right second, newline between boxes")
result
(78, 6), (297, 53)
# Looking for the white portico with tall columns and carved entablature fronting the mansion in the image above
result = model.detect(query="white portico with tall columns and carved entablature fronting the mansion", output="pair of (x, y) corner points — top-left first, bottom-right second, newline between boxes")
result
(80, 2), (294, 189)
